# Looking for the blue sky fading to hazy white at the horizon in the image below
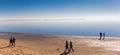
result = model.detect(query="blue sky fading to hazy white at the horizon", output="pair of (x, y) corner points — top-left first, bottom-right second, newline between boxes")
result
(0, 0), (120, 22)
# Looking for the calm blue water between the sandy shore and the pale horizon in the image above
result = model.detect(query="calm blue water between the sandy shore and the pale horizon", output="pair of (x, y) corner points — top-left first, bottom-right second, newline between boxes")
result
(0, 21), (120, 37)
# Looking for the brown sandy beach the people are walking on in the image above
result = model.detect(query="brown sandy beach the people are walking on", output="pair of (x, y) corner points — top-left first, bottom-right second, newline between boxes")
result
(0, 33), (120, 55)
